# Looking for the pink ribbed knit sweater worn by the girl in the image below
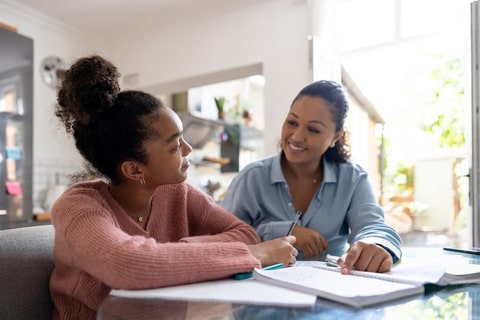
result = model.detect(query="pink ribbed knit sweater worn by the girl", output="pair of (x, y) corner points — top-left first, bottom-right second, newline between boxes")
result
(50, 181), (260, 320)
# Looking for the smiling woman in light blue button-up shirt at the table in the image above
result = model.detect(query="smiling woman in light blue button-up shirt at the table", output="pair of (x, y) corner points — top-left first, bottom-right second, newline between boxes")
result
(222, 81), (401, 273)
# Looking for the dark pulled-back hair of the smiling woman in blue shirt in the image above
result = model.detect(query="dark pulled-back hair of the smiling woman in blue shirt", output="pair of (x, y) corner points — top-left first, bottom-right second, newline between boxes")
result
(290, 80), (350, 162)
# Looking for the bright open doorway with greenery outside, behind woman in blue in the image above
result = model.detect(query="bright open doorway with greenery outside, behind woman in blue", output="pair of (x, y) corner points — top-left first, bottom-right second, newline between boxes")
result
(334, 0), (472, 247)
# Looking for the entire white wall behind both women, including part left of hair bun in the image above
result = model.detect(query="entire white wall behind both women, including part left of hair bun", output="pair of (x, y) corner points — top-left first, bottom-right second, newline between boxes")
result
(0, 0), (311, 208)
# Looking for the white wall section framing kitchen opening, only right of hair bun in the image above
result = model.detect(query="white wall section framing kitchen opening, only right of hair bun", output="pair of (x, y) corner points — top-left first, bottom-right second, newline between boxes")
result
(109, 0), (311, 154)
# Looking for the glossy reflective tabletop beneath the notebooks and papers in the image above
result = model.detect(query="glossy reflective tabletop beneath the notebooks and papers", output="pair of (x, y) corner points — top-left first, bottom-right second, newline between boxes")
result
(97, 248), (480, 320)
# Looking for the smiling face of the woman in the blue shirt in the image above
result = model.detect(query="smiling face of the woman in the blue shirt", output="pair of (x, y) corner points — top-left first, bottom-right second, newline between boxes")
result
(281, 96), (343, 164)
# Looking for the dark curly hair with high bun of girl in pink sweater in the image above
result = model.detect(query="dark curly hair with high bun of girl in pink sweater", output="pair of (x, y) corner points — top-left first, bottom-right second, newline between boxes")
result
(55, 55), (164, 183)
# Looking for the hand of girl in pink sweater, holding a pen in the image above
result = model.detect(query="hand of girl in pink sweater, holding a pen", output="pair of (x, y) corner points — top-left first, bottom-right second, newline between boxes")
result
(248, 236), (298, 267)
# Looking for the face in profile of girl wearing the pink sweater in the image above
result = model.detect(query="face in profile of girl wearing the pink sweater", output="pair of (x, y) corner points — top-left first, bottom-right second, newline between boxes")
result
(143, 108), (192, 185)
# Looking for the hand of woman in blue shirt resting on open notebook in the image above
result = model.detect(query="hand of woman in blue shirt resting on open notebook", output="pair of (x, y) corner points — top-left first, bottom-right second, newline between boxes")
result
(338, 241), (393, 274)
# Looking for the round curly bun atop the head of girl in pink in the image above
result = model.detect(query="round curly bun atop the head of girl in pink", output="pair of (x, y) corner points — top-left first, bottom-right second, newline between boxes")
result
(57, 55), (120, 124)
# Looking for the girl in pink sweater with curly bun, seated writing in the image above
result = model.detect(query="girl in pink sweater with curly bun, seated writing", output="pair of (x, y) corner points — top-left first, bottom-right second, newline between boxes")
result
(50, 56), (298, 319)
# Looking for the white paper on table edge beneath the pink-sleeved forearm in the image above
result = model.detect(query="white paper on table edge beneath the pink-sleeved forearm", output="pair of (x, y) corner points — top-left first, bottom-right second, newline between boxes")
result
(110, 279), (317, 307)
